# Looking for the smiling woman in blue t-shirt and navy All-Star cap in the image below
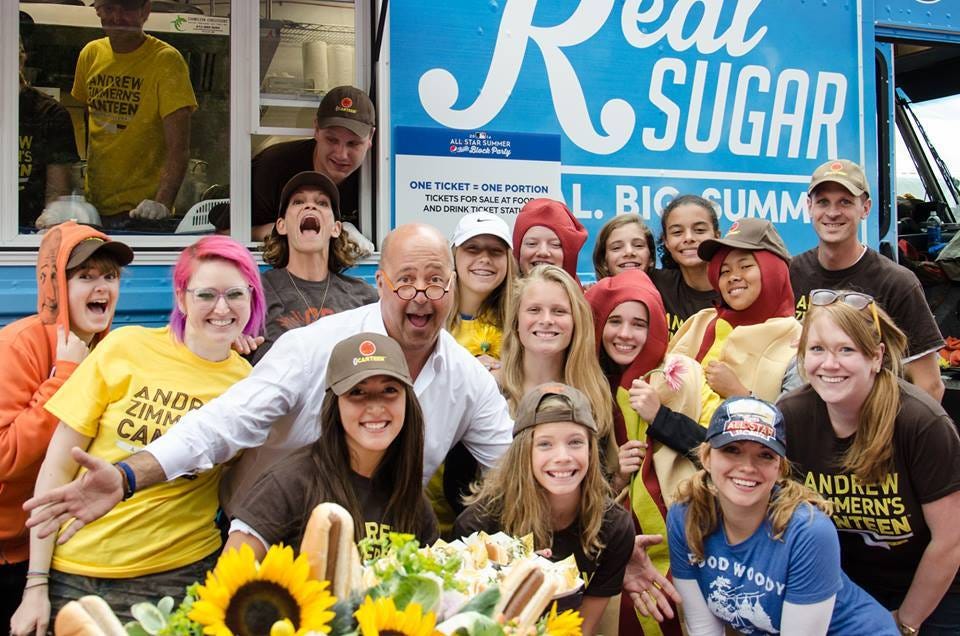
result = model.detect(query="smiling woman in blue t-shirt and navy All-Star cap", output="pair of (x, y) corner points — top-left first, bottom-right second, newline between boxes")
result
(667, 397), (898, 636)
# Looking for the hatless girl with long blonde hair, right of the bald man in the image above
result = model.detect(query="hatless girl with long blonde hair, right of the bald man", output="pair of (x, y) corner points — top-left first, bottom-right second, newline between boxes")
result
(498, 265), (613, 444)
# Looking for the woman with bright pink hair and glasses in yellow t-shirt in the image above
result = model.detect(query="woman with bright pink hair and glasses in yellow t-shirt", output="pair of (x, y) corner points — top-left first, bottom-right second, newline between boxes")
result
(10, 236), (264, 634)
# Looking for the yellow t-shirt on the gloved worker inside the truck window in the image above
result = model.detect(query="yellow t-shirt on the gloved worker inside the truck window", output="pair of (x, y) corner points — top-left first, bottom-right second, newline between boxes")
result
(71, 35), (197, 216)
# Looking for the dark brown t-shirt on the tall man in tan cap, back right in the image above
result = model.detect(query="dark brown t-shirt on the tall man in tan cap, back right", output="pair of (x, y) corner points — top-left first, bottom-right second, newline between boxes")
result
(790, 248), (943, 360)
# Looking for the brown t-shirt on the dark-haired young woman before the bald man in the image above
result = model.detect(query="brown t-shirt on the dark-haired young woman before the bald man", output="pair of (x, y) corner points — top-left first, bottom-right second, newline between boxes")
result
(235, 446), (439, 559)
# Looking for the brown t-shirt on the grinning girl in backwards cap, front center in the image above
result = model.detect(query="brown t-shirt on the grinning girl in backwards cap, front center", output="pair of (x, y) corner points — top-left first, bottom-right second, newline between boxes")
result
(453, 502), (635, 612)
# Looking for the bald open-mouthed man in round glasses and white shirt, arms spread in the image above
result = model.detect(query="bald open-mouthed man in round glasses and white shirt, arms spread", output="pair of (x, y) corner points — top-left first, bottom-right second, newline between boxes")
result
(24, 224), (513, 541)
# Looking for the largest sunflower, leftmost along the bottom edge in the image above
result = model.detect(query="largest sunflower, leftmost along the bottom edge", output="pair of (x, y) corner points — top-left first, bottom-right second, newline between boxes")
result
(190, 545), (336, 636)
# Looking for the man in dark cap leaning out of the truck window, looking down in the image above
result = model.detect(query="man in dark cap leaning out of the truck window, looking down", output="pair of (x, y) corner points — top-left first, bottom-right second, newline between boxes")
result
(248, 86), (377, 241)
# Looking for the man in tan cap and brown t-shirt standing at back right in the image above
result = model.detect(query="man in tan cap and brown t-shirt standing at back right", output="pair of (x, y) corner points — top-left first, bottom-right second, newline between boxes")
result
(790, 159), (944, 402)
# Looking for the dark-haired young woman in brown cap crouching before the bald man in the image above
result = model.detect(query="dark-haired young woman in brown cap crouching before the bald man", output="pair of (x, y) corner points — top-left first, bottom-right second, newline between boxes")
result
(224, 333), (437, 559)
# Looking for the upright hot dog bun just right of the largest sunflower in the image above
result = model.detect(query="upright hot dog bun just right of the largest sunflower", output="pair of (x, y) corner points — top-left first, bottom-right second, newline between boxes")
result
(300, 503), (361, 598)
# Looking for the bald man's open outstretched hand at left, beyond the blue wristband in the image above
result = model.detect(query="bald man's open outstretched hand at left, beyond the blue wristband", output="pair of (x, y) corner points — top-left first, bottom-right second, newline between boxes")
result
(23, 447), (123, 543)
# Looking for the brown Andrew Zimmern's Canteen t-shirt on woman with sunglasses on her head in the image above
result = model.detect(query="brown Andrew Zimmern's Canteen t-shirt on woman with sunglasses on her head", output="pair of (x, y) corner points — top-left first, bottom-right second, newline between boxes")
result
(777, 380), (960, 608)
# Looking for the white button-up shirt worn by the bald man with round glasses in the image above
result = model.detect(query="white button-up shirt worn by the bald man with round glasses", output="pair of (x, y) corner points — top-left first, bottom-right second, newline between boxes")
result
(146, 303), (513, 501)
